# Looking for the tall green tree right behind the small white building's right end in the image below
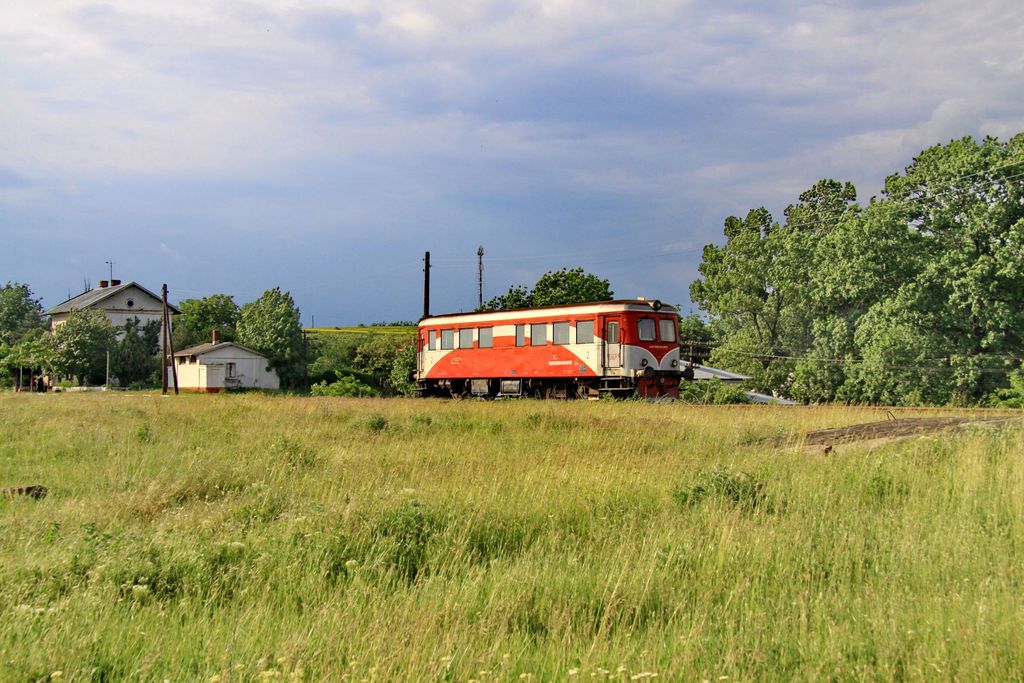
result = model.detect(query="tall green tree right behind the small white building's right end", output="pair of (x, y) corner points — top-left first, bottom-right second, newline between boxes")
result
(236, 287), (306, 387)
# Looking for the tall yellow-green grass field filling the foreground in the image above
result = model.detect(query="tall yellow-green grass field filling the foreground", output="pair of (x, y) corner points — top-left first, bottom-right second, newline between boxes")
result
(0, 393), (1024, 681)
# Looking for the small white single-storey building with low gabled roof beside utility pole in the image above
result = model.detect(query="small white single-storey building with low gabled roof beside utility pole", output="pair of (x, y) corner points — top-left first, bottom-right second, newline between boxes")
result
(174, 337), (281, 393)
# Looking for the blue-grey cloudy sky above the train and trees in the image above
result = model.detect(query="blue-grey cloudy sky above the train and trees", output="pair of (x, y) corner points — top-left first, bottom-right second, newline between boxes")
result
(0, 0), (1024, 326)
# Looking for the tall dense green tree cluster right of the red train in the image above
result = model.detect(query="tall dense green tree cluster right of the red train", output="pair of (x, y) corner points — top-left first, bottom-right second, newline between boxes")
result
(684, 134), (1024, 404)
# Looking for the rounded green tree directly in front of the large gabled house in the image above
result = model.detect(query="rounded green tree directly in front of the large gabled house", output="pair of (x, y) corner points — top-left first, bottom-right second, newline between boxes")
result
(52, 308), (117, 386)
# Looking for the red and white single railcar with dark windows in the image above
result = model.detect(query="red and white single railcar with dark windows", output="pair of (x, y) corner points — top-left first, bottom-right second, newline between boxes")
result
(413, 299), (693, 399)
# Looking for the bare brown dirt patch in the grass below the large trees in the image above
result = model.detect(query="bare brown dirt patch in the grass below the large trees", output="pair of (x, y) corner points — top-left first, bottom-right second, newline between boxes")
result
(772, 415), (1021, 453)
